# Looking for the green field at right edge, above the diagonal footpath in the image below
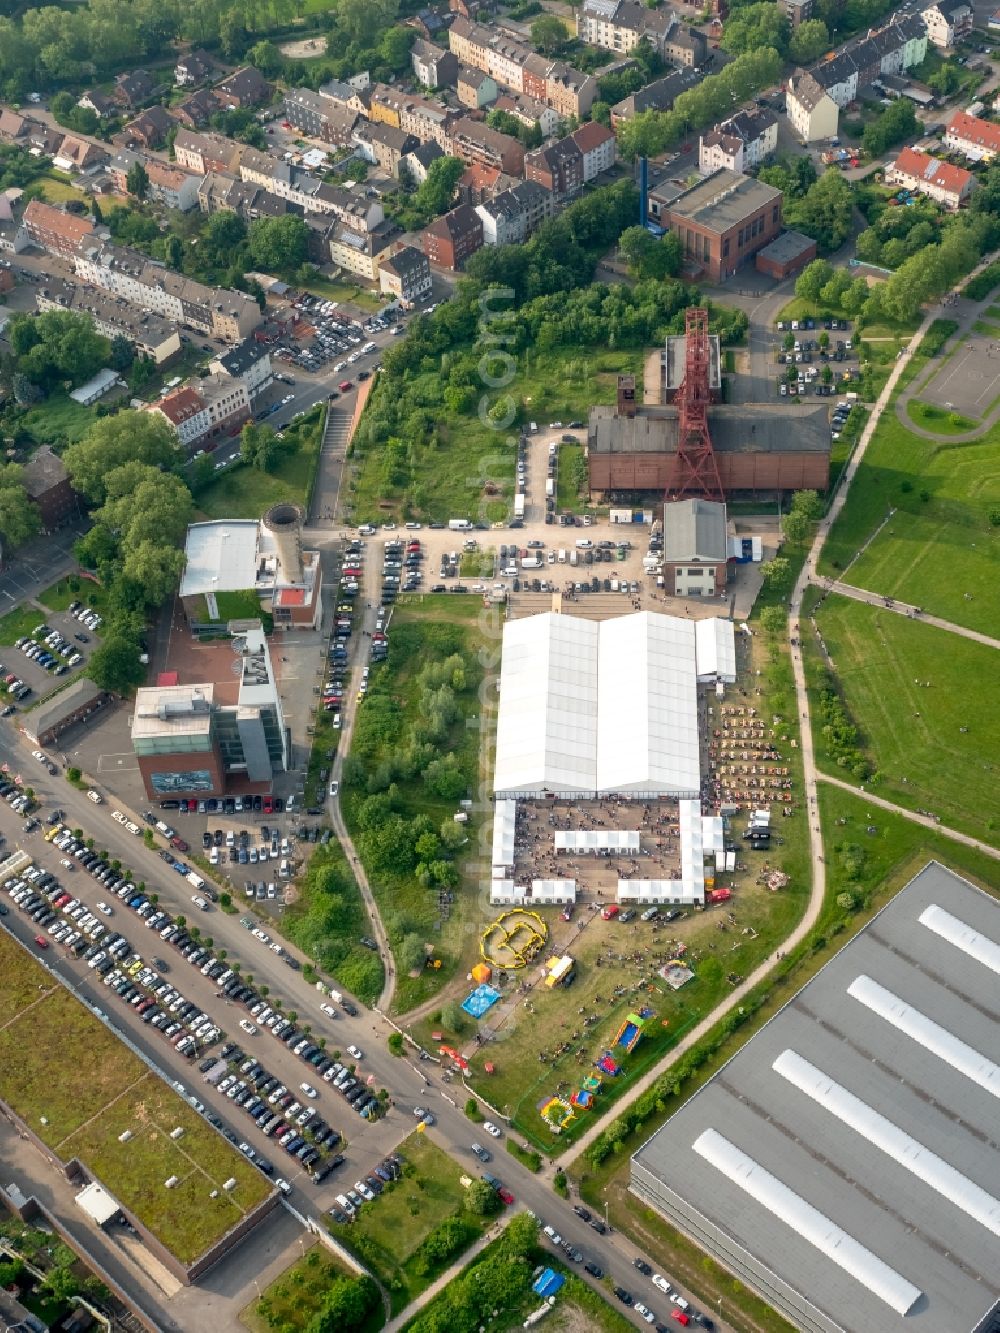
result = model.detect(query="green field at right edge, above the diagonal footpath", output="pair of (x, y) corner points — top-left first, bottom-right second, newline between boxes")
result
(820, 330), (1000, 635)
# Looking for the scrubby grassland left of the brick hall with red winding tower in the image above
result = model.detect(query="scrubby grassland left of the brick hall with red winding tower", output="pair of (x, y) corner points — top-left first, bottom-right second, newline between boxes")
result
(347, 348), (643, 523)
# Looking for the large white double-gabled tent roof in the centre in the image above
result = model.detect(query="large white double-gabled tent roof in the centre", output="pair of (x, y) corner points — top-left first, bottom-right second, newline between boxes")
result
(493, 612), (700, 796)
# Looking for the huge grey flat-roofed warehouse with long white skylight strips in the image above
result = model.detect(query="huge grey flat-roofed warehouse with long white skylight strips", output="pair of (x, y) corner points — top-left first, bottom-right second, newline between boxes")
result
(631, 862), (1000, 1333)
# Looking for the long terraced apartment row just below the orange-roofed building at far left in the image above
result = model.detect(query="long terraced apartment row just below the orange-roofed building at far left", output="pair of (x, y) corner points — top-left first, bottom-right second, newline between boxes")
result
(73, 243), (261, 343)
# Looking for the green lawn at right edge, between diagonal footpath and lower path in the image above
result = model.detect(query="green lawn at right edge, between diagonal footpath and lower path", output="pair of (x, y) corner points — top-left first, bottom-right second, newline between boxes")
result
(807, 596), (1000, 844)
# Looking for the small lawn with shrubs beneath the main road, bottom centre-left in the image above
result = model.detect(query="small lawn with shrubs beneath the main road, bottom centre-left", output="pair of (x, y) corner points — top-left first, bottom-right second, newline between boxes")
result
(332, 1133), (491, 1314)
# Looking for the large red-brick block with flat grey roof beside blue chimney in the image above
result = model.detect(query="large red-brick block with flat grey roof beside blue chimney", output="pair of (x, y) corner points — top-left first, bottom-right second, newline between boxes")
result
(655, 169), (781, 283)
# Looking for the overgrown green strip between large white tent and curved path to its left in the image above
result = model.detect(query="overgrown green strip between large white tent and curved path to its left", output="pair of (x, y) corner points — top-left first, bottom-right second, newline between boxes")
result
(343, 593), (500, 1013)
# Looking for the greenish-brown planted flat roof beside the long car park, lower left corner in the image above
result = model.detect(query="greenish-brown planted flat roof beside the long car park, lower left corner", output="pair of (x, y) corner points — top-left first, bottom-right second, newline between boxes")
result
(0, 933), (272, 1262)
